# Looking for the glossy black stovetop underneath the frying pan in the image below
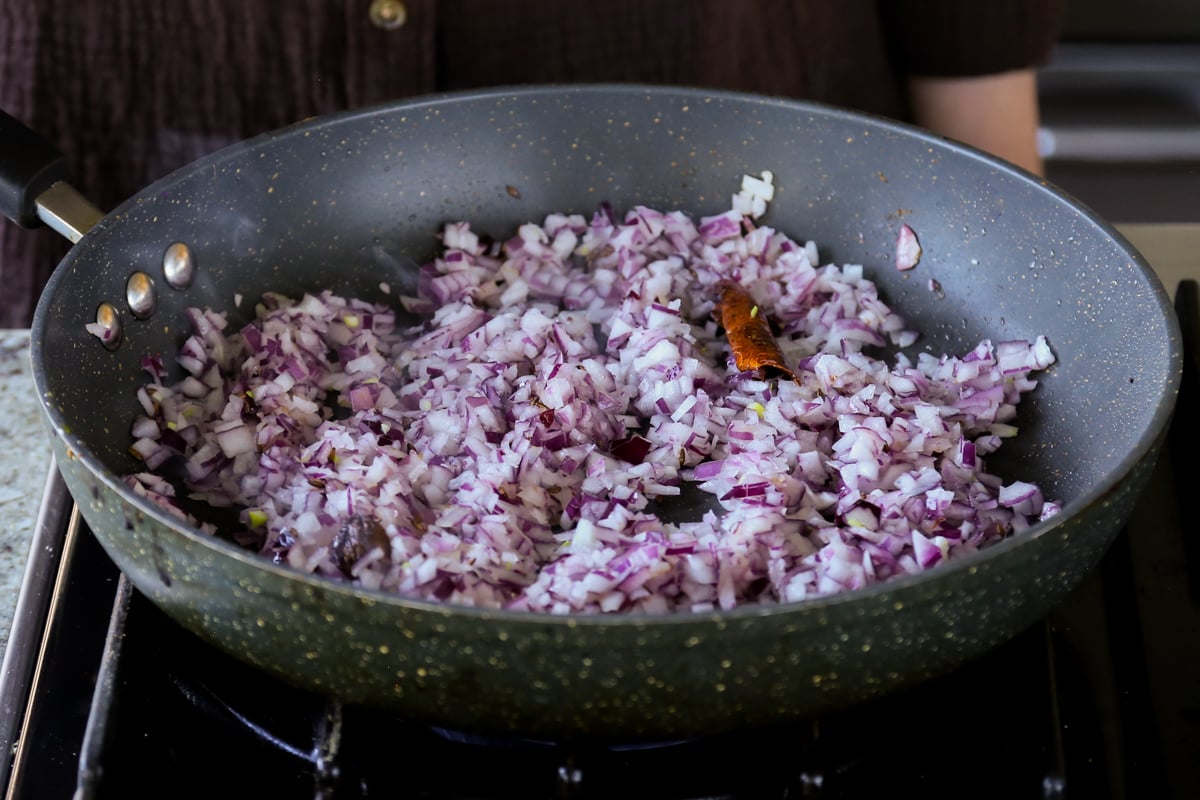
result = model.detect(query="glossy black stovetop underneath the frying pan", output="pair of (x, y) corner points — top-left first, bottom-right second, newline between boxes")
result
(0, 284), (1200, 800)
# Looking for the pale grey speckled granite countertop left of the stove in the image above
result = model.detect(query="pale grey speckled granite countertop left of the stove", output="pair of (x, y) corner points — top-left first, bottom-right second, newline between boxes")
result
(0, 330), (50, 654)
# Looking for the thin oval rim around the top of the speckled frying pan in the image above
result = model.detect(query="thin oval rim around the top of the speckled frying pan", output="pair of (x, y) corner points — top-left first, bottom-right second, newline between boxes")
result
(30, 83), (1182, 628)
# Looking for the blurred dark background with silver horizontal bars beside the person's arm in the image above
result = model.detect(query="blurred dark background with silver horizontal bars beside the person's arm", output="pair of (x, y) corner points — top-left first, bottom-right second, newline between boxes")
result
(1039, 0), (1200, 222)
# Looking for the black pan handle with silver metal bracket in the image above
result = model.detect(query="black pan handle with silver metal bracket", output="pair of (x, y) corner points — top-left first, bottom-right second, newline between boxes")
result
(0, 110), (104, 241)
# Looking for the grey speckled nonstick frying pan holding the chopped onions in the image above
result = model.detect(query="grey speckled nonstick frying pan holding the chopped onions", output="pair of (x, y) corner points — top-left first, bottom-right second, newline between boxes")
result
(4, 85), (1181, 739)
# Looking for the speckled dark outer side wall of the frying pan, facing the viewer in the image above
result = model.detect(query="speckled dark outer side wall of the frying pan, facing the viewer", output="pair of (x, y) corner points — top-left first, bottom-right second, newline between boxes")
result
(59, 447), (1148, 739)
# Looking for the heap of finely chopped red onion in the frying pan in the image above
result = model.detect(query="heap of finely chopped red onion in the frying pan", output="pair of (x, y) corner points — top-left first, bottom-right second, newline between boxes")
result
(128, 173), (1060, 613)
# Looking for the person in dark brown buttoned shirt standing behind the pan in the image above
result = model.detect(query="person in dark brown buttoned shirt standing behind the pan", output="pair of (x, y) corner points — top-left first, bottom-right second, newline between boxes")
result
(0, 0), (1066, 327)
